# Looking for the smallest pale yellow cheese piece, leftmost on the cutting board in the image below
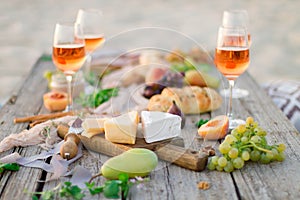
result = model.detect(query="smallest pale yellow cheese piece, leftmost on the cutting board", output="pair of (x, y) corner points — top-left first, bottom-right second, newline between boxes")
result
(82, 118), (108, 133)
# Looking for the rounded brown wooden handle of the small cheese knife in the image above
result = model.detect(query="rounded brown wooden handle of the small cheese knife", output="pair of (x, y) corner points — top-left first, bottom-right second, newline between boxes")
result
(60, 133), (80, 160)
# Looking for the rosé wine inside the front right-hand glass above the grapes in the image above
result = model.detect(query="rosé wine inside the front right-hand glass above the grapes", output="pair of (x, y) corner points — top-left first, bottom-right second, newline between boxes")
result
(215, 47), (250, 80)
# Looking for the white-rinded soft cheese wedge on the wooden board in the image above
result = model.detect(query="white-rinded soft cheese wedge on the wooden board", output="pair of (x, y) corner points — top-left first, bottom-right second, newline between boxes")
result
(141, 111), (181, 143)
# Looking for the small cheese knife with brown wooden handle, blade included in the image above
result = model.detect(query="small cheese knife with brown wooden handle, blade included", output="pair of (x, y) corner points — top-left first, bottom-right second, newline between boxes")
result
(60, 117), (84, 160)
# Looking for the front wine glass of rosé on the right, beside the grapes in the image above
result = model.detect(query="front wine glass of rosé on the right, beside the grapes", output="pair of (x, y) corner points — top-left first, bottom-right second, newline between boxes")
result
(214, 26), (250, 129)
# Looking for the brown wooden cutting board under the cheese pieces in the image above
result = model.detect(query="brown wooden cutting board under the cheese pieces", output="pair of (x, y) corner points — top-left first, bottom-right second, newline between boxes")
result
(79, 134), (208, 171)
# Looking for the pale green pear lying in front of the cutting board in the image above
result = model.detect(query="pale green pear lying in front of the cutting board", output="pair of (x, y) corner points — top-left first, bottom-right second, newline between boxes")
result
(101, 148), (158, 179)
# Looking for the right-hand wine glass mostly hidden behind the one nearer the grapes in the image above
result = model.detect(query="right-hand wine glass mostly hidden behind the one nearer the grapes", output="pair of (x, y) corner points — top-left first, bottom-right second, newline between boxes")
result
(220, 10), (251, 98)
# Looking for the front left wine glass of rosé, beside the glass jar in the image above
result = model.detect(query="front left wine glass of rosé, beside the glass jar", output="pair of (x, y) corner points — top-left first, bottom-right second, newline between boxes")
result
(52, 23), (85, 111)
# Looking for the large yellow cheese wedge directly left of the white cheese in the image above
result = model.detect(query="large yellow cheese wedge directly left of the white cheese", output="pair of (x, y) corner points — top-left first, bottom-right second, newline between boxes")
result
(104, 111), (139, 144)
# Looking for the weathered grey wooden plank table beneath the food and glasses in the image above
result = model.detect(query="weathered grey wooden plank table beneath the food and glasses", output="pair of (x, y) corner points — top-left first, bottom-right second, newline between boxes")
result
(0, 56), (300, 200)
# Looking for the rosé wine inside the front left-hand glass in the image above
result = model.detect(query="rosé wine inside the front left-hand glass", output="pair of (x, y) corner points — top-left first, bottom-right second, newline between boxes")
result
(52, 44), (85, 74)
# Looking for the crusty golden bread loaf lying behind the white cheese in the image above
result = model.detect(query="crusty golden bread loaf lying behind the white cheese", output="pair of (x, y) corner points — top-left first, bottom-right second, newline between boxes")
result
(148, 86), (222, 114)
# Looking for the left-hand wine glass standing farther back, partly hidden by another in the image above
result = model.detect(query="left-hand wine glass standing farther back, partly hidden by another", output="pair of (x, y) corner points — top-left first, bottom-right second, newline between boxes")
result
(76, 9), (105, 75)
